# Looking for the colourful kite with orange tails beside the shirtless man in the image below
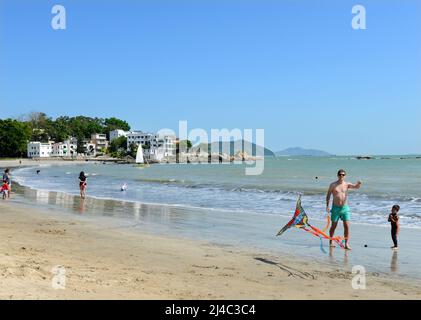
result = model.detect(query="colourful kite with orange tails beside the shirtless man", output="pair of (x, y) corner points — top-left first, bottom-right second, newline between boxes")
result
(276, 196), (345, 252)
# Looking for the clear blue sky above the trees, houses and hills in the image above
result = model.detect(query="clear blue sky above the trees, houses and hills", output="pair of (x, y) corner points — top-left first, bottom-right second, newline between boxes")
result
(0, 0), (421, 155)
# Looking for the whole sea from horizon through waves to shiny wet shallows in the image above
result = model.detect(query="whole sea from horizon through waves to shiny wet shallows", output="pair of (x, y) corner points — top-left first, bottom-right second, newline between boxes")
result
(7, 156), (421, 281)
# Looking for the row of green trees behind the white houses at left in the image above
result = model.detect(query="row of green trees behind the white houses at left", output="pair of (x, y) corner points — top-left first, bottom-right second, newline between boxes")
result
(0, 112), (130, 157)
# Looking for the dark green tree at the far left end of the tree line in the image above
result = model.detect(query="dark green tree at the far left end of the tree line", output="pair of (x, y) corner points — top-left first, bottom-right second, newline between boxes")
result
(0, 119), (31, 157)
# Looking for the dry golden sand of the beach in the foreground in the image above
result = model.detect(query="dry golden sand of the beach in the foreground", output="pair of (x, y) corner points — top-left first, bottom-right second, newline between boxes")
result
(0, 200), (421, 299)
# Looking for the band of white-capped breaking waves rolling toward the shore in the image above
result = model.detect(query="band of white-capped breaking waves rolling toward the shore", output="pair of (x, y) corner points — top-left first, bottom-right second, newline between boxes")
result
(10, 164), (421, 226)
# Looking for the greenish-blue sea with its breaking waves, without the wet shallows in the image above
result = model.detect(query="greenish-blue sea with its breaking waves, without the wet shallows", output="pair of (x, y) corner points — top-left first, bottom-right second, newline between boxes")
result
(13, 156), (421, 228)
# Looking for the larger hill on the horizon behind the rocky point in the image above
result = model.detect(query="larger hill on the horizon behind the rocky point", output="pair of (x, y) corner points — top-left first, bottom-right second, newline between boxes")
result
(191, 140), (275, 157)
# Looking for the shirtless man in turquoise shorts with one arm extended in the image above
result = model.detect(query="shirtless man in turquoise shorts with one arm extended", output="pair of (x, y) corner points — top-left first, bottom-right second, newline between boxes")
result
(326, 169), (362, 250)
